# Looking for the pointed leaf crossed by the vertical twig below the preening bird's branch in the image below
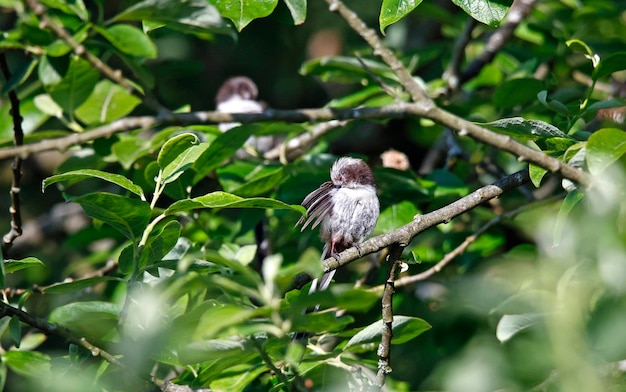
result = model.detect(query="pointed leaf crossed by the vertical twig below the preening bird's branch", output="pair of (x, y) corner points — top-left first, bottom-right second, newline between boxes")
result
(345, 315), (431, 349)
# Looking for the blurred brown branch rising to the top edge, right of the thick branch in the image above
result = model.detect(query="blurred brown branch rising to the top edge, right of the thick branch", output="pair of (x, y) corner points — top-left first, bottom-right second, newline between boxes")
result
(450, 0), (537, 87)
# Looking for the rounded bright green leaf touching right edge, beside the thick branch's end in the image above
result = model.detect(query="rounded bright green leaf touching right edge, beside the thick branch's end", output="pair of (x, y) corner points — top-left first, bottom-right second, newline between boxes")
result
(586, 128), (626, 175)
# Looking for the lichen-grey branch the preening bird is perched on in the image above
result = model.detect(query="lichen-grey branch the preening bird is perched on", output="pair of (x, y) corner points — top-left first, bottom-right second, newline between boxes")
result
(323, 170), (530, 272)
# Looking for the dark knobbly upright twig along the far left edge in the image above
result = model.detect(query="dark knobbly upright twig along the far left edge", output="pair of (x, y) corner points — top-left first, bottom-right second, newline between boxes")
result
(0, 52), (24, 258)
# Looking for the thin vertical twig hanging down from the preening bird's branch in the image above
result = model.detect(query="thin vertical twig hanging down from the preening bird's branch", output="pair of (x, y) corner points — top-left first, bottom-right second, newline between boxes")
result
(376, 245), (404, 387)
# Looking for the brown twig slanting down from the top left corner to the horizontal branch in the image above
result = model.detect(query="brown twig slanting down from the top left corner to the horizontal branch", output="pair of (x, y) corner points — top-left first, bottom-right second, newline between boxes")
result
(26, 0), (169, 113)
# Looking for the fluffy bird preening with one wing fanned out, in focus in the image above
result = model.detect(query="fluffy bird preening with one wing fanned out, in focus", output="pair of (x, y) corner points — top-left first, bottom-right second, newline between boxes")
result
(296, 157), (380, 294)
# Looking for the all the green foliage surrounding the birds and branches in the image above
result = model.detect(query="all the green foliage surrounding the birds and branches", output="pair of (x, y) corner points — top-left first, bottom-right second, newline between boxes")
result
(0, 0), (626, 391)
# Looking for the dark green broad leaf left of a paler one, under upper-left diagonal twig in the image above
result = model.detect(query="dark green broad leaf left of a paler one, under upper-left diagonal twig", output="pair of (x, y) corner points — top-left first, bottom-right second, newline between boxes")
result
(47, 56), (100, 115)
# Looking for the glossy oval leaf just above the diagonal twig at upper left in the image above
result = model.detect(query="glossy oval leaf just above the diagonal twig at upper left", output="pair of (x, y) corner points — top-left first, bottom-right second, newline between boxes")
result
(94, 24), (157, 59)
